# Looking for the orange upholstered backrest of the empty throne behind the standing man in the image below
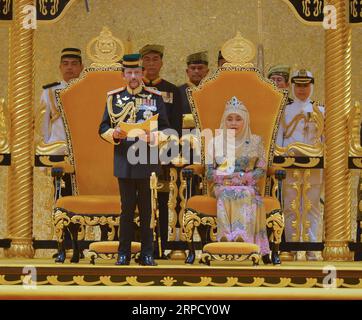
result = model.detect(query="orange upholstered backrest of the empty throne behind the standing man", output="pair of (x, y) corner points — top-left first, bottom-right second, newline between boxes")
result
(57, 67), (125, 195)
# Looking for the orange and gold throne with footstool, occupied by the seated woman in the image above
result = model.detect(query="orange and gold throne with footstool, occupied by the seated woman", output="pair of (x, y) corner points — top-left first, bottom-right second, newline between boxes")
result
(183, 34), (287, 265)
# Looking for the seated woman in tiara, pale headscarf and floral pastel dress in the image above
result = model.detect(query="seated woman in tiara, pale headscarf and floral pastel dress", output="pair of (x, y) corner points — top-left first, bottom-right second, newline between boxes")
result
(206, 97), (270, 263)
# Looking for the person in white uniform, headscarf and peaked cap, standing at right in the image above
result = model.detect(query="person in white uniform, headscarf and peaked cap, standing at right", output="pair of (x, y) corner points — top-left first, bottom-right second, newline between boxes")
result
(277, 70), (324, 260)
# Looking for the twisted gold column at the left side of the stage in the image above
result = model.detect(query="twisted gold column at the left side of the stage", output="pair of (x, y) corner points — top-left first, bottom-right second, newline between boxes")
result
(5, 0), (34, 258)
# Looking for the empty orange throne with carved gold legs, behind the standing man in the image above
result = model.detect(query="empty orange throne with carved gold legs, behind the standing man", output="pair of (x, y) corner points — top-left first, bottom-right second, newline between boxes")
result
(52, 67), (131, 262)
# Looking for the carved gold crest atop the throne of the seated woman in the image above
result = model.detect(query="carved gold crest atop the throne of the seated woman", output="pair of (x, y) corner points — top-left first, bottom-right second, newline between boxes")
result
(221, 32), (256, 67)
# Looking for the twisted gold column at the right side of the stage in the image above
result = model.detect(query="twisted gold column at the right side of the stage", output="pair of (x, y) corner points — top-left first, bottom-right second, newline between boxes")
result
(323, 0), (351, 261)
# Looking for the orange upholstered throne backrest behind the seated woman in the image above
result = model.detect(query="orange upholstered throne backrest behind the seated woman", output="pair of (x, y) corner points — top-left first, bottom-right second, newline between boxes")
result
(188, 66), (287, 195)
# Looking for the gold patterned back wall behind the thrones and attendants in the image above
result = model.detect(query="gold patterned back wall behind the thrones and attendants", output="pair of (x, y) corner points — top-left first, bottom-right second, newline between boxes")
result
(0, 0), (362, 250)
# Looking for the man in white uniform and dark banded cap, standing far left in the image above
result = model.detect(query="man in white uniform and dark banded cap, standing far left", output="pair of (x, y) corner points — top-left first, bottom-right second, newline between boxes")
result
(40, 48), (83, 155)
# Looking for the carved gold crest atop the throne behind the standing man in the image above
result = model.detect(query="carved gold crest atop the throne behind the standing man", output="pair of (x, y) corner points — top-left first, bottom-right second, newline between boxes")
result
(87, 27), (124, 67)
